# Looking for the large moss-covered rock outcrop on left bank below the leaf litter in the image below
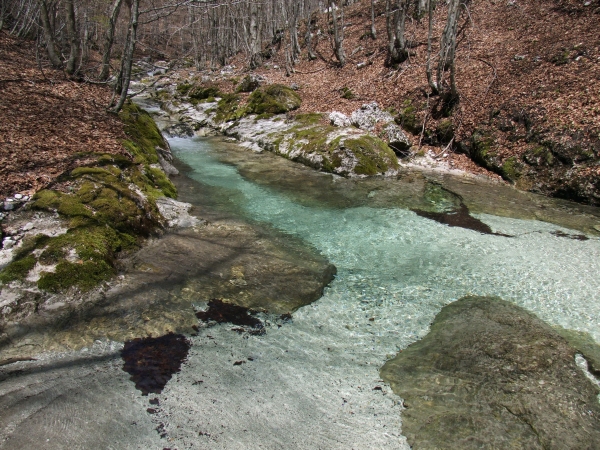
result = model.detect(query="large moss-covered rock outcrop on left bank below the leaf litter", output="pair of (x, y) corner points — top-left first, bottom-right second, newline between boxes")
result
(0, 104), (177, 292)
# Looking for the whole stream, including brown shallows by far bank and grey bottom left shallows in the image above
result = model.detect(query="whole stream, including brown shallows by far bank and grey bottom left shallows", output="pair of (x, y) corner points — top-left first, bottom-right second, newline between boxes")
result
(0, 134), (600, 449)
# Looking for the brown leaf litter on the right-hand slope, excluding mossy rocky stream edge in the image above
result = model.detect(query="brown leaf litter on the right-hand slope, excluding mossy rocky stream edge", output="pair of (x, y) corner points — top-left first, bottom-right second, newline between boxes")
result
(234, 0), (600, 183)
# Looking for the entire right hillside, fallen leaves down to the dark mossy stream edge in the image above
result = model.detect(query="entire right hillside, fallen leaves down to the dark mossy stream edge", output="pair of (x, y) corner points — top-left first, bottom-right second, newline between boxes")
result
(244, 0), (600, 205)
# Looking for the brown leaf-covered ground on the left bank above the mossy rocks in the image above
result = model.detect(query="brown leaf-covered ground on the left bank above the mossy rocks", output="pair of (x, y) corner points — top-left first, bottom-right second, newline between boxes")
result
(0, 32), (125, 200)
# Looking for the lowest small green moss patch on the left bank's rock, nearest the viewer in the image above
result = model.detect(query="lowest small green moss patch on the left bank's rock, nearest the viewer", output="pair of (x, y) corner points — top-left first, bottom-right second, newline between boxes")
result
(37, 261), (115, 292)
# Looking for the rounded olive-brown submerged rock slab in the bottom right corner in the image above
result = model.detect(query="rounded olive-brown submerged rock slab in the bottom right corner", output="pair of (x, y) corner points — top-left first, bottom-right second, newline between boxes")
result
(381, 297), (600, 449)
